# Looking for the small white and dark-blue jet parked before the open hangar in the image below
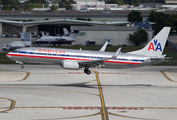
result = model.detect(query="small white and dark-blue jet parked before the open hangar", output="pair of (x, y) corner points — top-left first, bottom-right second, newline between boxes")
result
(33, 29), (79, 46)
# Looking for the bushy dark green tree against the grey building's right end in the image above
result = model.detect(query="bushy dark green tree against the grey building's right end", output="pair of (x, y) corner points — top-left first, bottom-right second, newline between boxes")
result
(128, 29), (148, 46)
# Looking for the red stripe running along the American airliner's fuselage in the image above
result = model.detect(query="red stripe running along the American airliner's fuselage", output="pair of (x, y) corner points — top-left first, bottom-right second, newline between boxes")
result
(7, 53), (141, 65)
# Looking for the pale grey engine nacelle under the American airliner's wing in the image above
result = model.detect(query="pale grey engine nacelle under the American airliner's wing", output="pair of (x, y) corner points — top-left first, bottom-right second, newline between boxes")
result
(62, 60), (79, 70)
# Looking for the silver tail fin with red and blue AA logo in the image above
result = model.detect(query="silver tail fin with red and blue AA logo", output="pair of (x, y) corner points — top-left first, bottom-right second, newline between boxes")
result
(129, 27), (171, 57)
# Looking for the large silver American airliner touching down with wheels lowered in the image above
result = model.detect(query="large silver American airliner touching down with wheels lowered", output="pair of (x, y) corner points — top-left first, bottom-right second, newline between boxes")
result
(6, 27), (171, 75)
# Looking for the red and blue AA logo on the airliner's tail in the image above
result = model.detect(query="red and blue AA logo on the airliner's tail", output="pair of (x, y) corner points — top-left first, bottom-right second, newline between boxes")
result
(148, 39), (162, 51)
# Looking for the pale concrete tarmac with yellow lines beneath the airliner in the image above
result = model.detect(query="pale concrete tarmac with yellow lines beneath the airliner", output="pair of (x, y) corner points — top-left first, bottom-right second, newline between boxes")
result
(0, 65), (177, 120)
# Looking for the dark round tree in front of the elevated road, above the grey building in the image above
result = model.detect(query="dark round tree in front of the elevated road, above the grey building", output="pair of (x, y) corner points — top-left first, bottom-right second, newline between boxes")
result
(127, 10), (143, 24)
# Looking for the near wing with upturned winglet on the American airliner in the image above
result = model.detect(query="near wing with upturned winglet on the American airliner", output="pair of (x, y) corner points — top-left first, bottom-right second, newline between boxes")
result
(78, 48), (121, 67)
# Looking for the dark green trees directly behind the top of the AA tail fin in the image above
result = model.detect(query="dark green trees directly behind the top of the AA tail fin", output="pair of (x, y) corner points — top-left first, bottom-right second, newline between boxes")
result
(148, 11), (170, 35)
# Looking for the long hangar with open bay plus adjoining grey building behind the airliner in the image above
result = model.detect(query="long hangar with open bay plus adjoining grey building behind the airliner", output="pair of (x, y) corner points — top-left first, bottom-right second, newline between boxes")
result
(0, 19), (153, 46)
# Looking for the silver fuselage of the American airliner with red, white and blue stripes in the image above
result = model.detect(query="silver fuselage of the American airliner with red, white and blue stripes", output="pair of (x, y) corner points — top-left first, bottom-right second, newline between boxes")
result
(7, 47), (161, 68)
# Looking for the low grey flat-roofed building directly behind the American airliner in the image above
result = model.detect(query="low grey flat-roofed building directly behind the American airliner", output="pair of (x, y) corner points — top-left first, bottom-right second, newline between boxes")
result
(72, 26), (153, 46)
